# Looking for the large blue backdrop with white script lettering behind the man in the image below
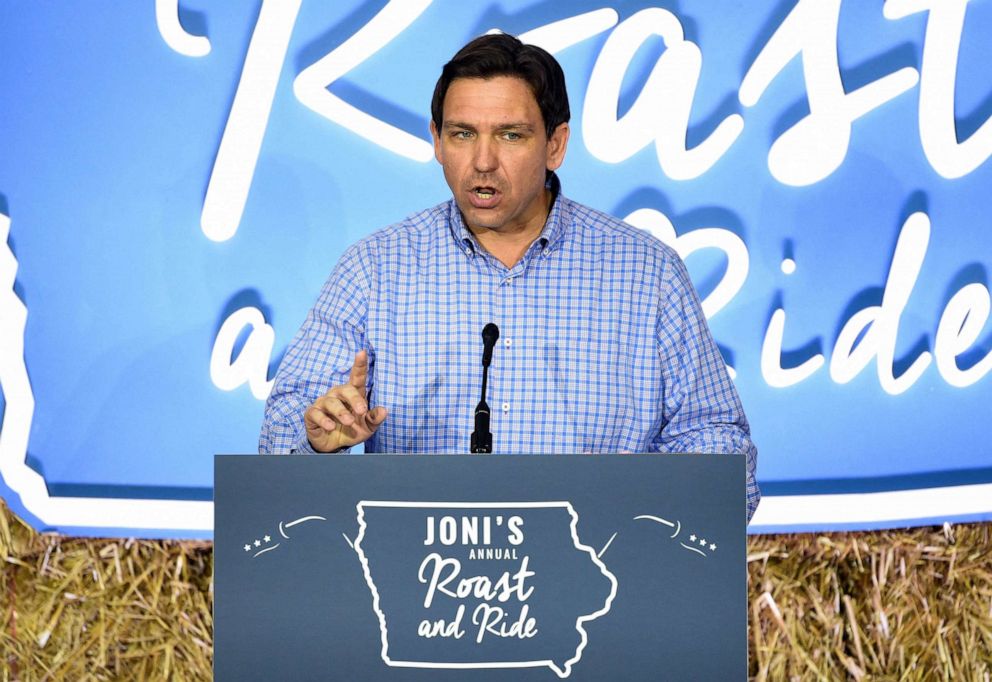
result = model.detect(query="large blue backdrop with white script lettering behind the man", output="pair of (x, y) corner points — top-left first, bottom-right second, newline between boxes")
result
(0, 0), (992, 537)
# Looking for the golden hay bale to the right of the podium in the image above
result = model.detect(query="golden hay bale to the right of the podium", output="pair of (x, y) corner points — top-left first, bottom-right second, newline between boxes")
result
(748, 524), (992, 682)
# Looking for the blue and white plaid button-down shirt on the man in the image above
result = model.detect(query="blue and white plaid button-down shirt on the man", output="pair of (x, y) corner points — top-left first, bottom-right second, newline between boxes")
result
(259, 178), (759, 519)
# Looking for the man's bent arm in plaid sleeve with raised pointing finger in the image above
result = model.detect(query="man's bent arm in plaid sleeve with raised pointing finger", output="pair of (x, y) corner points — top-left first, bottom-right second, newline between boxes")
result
(258, 242), (385, 454)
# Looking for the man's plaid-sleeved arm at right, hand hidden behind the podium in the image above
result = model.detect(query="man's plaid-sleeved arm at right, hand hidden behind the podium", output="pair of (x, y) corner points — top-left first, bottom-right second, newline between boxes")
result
(657, 253), (761, 521)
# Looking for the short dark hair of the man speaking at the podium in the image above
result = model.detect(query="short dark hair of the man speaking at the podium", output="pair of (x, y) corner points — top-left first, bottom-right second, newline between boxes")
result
(431, 33), (571, 139)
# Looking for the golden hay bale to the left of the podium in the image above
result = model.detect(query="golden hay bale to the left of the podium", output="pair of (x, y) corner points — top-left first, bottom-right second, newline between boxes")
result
(0, 496), (213, 682)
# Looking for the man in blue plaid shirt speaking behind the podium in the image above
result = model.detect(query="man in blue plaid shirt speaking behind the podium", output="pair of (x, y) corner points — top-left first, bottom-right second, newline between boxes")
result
(259, 35), (759, 519)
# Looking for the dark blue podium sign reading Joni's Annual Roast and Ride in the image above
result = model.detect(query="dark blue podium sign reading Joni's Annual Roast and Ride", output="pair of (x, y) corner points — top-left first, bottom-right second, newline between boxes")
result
(214, 455), (747, 681)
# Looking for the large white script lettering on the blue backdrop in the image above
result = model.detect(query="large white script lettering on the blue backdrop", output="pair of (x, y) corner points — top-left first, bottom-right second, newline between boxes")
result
(194, 0), (992, 399)
